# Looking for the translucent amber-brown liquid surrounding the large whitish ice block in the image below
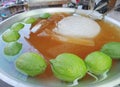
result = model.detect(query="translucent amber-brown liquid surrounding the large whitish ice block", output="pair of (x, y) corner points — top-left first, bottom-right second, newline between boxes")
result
(26, 13), (120, 79)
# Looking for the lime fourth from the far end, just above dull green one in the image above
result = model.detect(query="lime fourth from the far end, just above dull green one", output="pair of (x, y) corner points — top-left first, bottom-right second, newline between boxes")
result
(2, 29), (20, 42)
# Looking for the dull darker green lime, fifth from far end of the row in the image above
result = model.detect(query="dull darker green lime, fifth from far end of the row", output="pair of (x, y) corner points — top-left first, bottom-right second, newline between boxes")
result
(4, 42), (22, 56)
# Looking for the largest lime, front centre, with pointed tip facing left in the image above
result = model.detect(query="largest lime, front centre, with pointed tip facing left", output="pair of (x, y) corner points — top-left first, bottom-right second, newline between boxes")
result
(50, 53), (87, 82)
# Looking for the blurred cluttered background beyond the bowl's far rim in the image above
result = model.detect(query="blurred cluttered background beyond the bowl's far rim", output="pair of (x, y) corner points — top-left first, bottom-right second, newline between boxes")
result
(0, 0), (120, 21)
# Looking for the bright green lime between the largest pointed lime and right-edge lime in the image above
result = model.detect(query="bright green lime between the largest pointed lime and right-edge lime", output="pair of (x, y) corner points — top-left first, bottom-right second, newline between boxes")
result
(85, 51), (112, 75)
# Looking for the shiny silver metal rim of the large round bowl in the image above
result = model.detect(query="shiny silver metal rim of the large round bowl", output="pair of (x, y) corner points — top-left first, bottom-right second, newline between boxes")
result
(0, 8), (120, 87)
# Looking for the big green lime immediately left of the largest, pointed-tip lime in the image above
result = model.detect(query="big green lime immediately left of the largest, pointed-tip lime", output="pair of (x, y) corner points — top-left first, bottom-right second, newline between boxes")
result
(15, 52), (47, 76)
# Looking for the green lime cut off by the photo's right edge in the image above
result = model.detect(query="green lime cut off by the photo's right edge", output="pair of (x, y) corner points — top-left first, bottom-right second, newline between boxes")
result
(101, 42), (120, 59)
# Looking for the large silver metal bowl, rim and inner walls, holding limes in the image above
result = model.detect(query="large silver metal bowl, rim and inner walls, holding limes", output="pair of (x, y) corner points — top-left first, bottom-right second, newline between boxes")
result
(0, 8), (120, 87)
